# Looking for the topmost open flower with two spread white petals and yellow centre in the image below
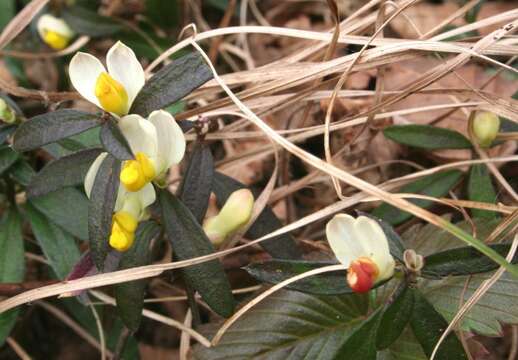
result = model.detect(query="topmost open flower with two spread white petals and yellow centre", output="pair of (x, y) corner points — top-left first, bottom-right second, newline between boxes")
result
(69, 41), (145, 116)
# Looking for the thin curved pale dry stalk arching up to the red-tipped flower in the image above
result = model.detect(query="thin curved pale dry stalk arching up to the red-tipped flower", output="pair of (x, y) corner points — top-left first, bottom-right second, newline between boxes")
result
(211, 264), (347, 346)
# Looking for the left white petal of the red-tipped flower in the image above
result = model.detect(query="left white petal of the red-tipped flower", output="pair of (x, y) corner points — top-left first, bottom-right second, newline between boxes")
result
(326, 214), (366, 267)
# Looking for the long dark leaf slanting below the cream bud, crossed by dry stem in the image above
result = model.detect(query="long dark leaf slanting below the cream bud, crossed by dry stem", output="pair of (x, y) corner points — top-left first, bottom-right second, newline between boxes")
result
(158, 190), (235, 317)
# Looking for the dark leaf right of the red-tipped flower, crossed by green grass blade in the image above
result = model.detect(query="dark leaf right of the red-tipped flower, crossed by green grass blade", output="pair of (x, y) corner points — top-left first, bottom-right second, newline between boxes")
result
(422, 244), (518, 278)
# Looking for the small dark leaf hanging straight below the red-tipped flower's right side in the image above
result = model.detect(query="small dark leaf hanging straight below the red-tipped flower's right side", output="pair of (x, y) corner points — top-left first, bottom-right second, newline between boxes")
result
(376, 284), (414, 350)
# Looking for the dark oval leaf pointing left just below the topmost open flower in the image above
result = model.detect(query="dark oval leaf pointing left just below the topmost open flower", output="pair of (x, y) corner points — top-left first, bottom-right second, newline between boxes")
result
(13, 109), (99, 151)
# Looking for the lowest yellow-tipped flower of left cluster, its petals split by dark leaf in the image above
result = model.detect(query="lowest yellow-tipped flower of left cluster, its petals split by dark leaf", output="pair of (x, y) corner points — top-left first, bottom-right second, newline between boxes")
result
(84, 153), (156, 251)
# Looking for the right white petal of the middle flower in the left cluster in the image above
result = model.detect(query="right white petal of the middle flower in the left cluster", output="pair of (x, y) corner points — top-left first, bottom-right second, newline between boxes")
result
(149, 110), (185, 173)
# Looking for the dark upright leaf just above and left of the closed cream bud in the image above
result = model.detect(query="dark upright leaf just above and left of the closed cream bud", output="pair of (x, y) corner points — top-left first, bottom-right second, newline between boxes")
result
(179, 143), (214, 224)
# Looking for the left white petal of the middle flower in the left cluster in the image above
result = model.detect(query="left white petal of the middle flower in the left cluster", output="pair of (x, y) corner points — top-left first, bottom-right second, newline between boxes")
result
(119, 115), (158, 159)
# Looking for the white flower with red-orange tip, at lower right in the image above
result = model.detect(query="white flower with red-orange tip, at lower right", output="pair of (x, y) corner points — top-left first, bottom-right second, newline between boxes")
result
(326, 214), (395, 292)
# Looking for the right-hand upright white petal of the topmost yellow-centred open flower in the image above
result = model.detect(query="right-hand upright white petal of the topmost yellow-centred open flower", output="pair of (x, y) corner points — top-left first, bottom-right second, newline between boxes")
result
(106, 41), (146, 107)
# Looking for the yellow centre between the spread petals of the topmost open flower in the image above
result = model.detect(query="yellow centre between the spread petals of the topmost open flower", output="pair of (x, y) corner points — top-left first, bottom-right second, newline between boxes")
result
(95, 72), (129, 116)
